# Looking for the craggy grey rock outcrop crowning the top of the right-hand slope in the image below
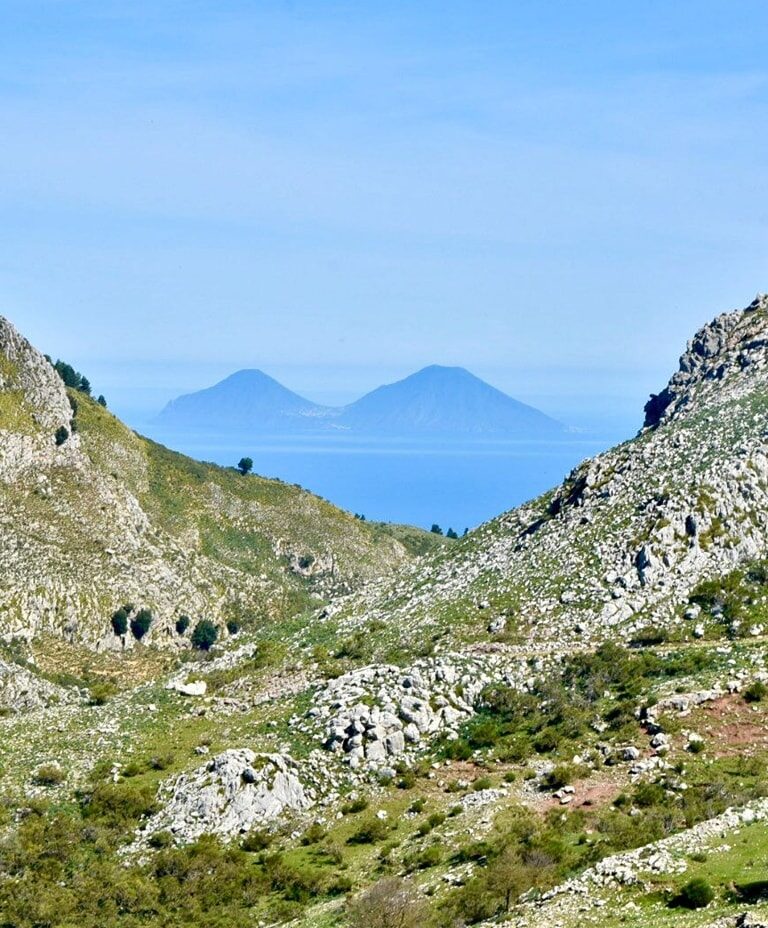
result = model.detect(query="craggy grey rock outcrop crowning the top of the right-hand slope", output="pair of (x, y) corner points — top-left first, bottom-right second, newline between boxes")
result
(644, 293), (768, 428)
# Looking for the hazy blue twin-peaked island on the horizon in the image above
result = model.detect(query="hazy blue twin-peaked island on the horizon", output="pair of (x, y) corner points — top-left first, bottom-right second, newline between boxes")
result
(153, 364), (568, 440)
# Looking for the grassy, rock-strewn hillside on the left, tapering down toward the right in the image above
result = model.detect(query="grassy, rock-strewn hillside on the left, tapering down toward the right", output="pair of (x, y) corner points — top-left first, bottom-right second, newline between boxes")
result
(0, 319), (420, 649)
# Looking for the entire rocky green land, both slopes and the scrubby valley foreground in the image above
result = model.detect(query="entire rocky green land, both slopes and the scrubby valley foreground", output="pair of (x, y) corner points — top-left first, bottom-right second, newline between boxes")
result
(0, 298), (768, 928)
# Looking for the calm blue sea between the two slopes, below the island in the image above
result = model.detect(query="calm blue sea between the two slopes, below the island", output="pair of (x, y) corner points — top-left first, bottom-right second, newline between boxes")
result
(144, 435), (613, 533)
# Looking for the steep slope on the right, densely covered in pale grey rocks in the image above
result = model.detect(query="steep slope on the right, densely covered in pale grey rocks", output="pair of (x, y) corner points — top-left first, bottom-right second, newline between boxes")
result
(337, 296), (768, 648)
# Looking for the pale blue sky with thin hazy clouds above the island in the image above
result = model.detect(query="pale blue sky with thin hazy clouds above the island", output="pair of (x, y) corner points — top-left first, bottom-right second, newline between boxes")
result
(0, 0), (768, 431)
